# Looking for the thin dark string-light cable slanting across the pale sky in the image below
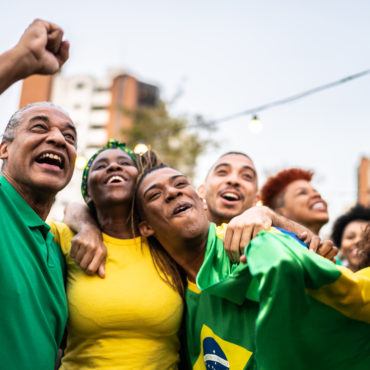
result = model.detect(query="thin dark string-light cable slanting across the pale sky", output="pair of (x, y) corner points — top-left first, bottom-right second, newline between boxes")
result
(203, 69), (370, 126)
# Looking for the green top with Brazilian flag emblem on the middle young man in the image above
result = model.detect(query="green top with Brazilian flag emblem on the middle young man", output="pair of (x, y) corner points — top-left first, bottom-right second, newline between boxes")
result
(186, 224), (258, 370)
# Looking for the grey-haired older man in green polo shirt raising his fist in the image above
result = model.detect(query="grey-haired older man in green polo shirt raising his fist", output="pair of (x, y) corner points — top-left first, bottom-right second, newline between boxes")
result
(0, 20), (76, 369)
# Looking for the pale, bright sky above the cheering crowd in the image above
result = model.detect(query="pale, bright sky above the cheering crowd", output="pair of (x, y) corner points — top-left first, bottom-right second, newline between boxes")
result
(0, 0), (370, 234)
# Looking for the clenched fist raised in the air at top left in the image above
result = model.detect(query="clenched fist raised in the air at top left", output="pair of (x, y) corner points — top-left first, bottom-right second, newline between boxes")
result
(14, 19), (69, 78)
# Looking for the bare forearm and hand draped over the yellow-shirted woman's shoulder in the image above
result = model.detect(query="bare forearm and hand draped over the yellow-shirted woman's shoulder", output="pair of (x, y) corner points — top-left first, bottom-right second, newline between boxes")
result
(64, 203), (107, 278)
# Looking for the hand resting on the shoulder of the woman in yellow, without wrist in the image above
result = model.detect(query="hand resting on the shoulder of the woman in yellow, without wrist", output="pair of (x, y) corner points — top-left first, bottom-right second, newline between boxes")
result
(70, 226), (107, 278)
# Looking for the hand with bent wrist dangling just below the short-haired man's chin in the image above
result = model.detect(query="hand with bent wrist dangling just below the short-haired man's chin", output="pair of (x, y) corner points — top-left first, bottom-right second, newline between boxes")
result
(224, 206), (272, 263)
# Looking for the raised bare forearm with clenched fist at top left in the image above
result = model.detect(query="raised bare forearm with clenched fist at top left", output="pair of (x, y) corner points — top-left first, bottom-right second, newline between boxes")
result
(0, 19), (69, 94)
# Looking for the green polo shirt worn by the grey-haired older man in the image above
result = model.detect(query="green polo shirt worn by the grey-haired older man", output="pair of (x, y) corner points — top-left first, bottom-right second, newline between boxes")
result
(0, 175), (67, 370)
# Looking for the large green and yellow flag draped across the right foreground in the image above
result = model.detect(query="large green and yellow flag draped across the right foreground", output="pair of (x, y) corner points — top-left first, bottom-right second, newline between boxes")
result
(197, 225), (370, 370)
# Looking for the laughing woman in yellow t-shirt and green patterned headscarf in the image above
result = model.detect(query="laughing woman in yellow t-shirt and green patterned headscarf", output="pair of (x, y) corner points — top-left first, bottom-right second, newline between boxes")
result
(52, 140), (183, 370)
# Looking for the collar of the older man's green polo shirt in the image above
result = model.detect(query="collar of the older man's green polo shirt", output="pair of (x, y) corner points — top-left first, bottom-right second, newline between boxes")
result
(0, 175), (50, 231)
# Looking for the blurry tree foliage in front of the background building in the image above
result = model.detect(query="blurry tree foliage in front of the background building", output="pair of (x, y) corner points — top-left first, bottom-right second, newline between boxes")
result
(122, 102), (215, 180)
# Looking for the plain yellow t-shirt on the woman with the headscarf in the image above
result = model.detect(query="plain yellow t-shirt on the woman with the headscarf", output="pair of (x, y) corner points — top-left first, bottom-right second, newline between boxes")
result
(51, 223), (183, 370)
